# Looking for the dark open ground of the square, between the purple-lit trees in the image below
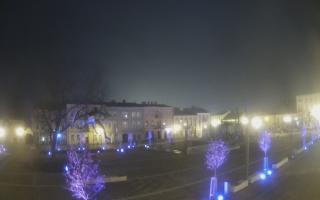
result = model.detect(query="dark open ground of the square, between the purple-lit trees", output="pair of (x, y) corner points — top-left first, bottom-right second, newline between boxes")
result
(0, 135), (298, 200)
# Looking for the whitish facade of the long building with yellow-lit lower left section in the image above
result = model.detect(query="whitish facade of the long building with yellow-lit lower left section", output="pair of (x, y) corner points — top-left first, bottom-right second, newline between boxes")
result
(66, 103), (173, 147)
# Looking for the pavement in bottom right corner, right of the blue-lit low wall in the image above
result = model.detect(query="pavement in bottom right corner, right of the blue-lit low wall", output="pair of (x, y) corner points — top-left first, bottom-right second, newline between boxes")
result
(232, 143), (320, 200)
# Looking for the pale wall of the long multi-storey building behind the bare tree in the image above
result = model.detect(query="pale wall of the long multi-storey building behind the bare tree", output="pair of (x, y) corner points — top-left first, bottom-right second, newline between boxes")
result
(67, 104), (173, 145)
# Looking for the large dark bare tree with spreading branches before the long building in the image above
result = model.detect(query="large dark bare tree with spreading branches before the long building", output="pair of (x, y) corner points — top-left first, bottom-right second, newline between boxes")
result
(32, 68), (108, 154)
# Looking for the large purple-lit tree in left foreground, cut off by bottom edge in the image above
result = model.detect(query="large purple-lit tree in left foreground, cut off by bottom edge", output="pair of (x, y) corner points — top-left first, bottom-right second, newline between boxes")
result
(64, 150), (105, 200)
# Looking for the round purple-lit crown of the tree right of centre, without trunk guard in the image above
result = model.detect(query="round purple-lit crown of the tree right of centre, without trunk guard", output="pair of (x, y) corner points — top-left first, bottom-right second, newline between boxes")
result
(206, 140), (229, 176)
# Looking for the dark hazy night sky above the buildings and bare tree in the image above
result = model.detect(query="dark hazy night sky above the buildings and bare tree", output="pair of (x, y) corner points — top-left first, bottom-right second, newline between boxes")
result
(0, 0), (320, 115)
